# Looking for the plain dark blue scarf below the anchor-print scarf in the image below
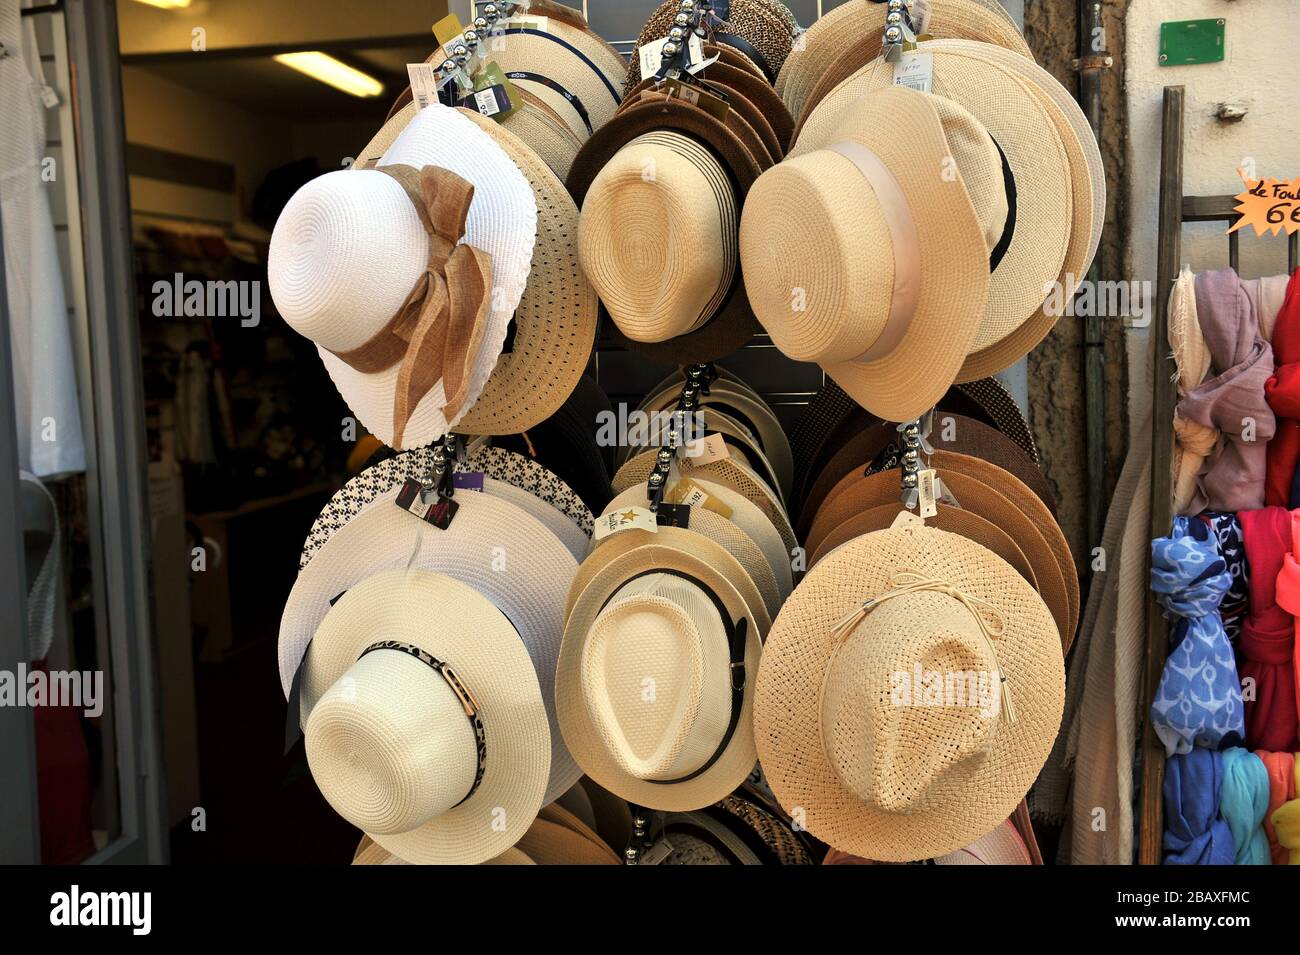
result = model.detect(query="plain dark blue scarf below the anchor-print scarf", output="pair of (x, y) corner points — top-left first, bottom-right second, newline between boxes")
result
(1165, 748), (1236, 865)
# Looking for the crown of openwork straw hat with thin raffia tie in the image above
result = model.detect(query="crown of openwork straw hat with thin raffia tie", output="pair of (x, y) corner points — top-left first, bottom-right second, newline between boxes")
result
(820, 590), (1001, 815)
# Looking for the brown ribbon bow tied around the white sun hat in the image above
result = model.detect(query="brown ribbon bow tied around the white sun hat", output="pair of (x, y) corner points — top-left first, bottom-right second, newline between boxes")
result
(334, 165), (491, 448)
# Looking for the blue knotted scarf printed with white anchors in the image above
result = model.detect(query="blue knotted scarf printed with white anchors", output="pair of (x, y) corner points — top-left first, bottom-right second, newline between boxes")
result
(1151, 517), (1244, 756)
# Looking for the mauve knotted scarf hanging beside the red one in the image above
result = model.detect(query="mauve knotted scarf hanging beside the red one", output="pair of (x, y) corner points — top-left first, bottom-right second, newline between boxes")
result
(1178, 269), (1277, 513)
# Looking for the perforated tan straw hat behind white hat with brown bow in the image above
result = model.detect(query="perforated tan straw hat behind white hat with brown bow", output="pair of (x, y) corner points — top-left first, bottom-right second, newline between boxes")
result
(354, 104), (598, 435)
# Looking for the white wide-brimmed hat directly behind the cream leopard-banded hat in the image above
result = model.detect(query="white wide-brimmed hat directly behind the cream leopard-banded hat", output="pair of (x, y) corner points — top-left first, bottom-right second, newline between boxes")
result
(280, 487), (581, 802)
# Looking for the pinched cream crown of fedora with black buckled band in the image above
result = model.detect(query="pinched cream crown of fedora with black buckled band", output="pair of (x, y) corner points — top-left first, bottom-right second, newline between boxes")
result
(581, 573), (731, 781)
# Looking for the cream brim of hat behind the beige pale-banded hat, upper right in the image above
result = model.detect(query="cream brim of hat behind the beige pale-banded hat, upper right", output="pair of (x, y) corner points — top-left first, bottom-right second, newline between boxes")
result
(790, 44), (1071, 381)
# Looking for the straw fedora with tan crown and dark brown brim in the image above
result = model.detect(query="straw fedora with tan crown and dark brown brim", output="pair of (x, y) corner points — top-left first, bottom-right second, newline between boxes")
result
(568, 91), (771, 364)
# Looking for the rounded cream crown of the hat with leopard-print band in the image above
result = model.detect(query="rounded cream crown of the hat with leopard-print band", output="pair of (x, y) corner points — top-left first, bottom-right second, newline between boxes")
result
(303, 650), (478, 835)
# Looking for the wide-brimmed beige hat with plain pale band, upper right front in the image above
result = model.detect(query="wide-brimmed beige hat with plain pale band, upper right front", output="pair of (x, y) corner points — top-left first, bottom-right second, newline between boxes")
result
(740, 87), (1008, 421)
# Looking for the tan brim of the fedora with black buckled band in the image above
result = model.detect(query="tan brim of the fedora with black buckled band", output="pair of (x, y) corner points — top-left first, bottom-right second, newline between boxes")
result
(555, 528), (771, 812)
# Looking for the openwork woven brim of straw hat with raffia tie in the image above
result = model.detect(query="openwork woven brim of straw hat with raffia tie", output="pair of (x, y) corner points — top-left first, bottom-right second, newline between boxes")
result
(754, 528), (1065, 861)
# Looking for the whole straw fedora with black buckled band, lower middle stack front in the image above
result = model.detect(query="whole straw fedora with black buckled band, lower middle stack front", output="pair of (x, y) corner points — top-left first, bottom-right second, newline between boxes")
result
(555, 528), (770, 811)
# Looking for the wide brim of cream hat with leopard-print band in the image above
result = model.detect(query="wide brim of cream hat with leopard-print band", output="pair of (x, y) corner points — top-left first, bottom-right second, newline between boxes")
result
(302, 569), (551, 865)
